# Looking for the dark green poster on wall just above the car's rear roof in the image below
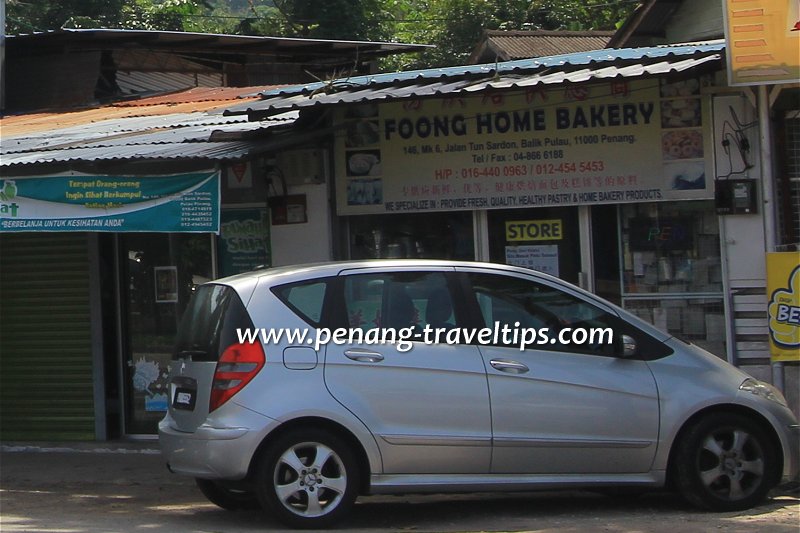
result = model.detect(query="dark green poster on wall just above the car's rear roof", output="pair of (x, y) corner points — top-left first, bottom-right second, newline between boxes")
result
(217, 208), (271, 277)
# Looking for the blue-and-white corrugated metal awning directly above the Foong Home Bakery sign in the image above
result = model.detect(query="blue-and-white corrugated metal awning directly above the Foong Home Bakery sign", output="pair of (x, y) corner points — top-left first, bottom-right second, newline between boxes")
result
(225, 43), (724, 119)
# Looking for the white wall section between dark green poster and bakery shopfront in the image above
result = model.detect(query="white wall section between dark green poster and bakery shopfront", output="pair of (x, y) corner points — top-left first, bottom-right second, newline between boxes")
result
(270, 183), (333, 266)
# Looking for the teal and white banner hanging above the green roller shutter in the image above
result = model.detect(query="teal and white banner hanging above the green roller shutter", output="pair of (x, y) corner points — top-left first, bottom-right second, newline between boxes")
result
(0, 171), (220, 233)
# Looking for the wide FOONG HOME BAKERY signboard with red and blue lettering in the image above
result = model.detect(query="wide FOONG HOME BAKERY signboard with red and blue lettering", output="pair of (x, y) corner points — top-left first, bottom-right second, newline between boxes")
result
(336, 79), (713, 215)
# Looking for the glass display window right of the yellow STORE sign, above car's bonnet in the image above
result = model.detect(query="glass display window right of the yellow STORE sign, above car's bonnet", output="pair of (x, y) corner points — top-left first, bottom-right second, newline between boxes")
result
(619, 201), (725, 358)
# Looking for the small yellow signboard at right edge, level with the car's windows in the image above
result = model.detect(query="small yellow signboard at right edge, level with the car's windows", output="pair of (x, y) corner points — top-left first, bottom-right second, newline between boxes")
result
(767, 252), (800, 361)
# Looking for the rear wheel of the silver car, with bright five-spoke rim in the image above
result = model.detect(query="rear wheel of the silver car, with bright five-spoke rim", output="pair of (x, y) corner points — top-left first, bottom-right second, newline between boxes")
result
(255, 428), (359, 529)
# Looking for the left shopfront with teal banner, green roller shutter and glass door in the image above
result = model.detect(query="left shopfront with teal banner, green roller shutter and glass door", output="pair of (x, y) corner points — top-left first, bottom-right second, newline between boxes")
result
(0, 152), (331, 440)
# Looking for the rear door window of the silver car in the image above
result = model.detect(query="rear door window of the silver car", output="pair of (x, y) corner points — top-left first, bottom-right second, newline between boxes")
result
(344, 272), (456, 332)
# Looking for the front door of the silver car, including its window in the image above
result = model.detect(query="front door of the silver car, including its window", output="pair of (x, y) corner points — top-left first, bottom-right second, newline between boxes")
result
(465, 270), (659, 474)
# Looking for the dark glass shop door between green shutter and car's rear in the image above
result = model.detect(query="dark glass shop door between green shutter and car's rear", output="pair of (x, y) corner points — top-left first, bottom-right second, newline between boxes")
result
(118, 233), (214, 435)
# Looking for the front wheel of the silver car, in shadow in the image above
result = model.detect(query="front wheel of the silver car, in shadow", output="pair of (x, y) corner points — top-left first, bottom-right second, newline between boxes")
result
(674, 413), (778, 511)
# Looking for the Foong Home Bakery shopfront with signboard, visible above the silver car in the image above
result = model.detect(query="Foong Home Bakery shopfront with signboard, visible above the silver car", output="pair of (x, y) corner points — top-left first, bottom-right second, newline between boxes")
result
(335, 72), (727, 358)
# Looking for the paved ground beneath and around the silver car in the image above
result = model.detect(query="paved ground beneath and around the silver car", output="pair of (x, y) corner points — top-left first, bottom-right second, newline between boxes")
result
(0, 443), (800, 533)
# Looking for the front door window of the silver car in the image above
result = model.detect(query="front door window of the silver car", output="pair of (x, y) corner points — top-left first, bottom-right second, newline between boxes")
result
(468, 273), (621, 356)
